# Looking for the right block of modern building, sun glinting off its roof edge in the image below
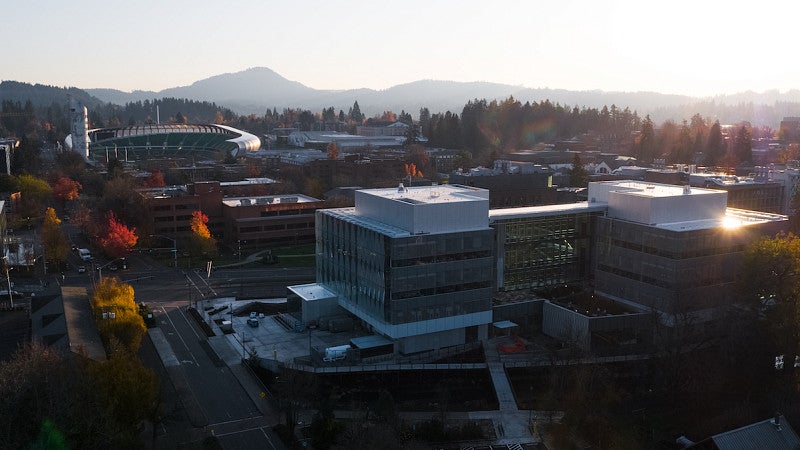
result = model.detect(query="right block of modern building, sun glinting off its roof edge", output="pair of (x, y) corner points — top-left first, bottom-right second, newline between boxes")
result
(589, 181), (787, 315)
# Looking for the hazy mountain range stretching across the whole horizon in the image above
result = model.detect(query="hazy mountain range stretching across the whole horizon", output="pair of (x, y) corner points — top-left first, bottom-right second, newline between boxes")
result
(7, 67), (800, 127)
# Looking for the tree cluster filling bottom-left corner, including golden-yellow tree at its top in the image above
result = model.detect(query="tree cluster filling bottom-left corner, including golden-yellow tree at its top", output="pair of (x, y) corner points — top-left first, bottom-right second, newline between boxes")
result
(0, 276), (163, 448)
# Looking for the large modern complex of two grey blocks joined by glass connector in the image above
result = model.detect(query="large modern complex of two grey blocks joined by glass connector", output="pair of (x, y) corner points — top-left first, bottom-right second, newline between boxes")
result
(288, 181), (787, 354)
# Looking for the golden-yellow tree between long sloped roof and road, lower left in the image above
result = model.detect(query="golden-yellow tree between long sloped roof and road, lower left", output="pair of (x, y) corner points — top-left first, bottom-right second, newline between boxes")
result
(91, 277), (147, 353)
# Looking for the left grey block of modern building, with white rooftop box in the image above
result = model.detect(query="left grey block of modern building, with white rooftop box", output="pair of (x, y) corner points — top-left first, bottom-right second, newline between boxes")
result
(316, 185), (494, 353)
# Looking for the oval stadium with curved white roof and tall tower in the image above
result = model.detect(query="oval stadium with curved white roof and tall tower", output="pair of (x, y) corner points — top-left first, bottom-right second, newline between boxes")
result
(65, 124), (261, 160)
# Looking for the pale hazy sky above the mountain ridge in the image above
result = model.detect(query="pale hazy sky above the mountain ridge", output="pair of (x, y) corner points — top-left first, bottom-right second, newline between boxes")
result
(6, 0), (800, 96)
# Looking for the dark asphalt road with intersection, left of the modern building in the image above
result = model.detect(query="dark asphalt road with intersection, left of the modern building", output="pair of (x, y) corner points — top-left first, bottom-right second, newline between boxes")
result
(62, 246), (294, 450)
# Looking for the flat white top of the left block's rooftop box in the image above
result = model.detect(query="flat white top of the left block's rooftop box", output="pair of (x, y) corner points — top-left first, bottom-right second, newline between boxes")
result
(359, 184), (489, 205)
